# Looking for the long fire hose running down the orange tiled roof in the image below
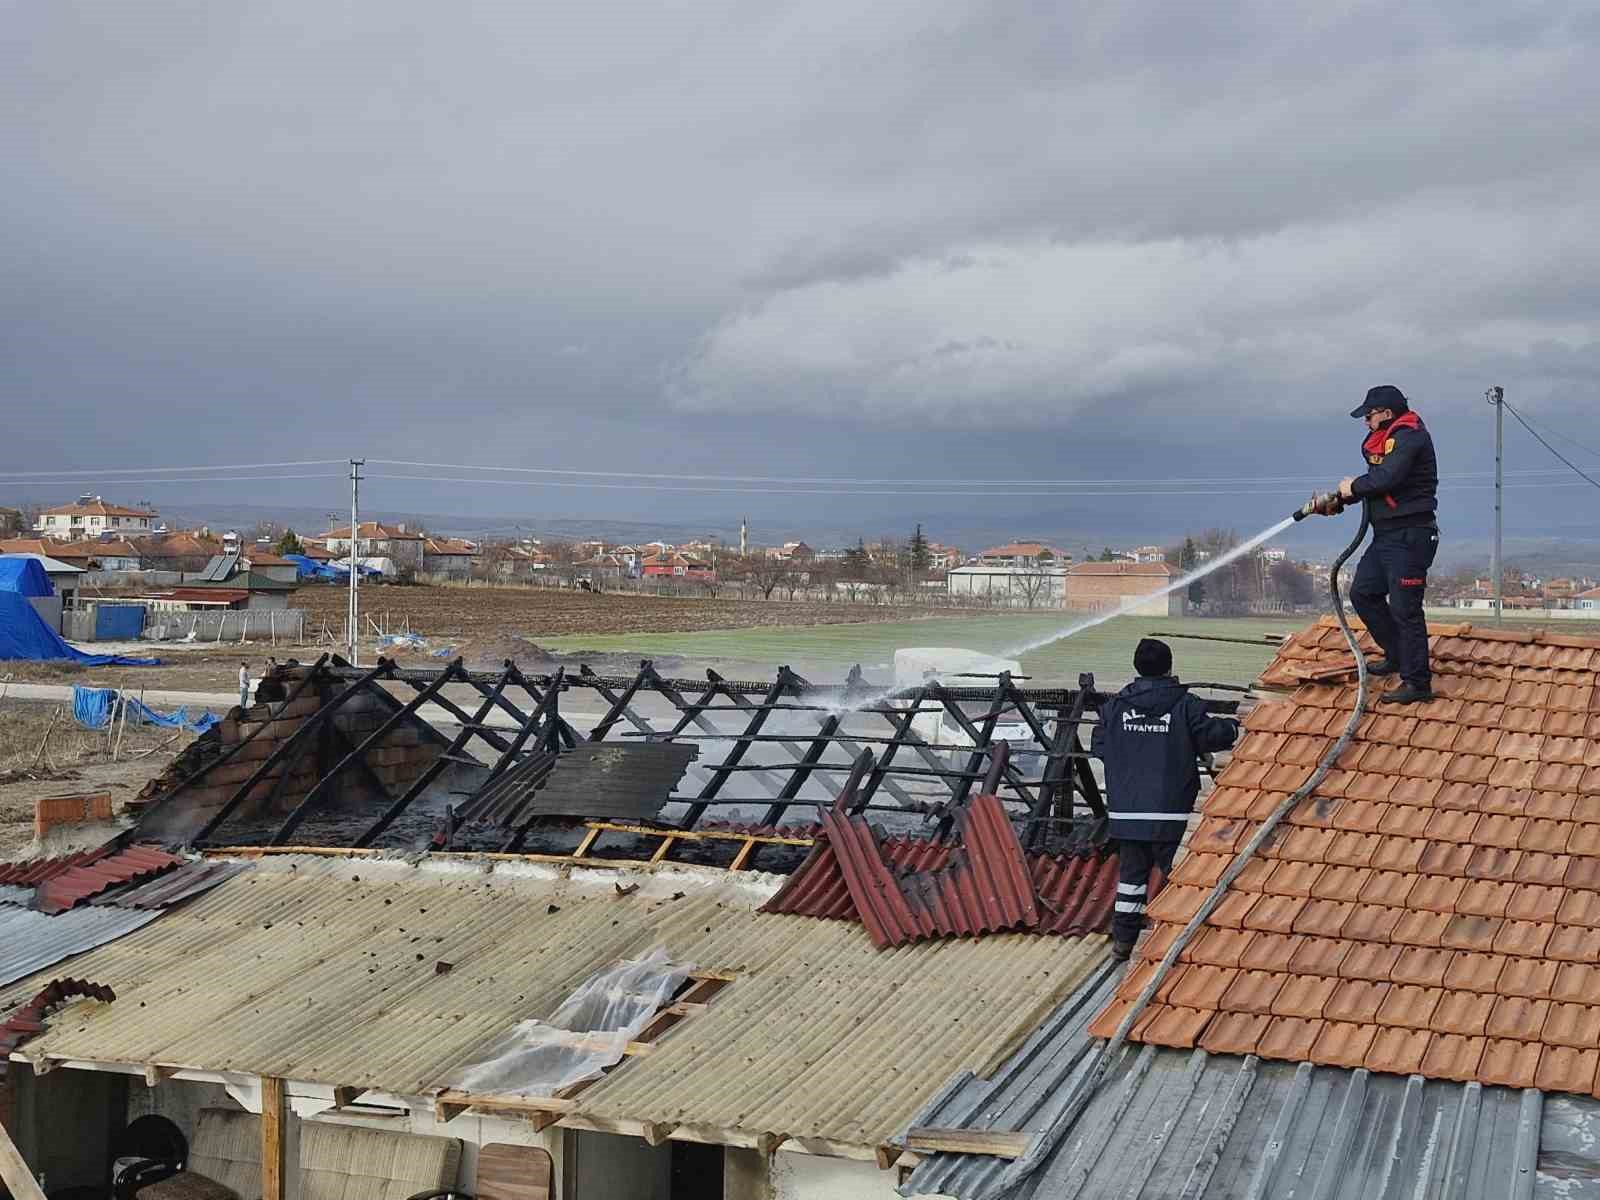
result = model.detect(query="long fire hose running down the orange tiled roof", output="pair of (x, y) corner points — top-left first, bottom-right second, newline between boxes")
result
(1029, 494), (1371, 1158)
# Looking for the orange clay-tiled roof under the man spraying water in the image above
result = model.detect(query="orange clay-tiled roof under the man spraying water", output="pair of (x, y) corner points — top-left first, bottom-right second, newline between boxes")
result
(1091, 621), (1600, 1093)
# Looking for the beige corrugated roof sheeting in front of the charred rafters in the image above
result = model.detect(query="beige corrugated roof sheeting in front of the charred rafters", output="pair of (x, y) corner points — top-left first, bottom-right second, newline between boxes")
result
(9, 856), (1107, 1146)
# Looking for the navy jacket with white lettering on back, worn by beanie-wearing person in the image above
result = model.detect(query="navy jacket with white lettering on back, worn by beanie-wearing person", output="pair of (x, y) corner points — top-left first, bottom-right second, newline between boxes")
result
(1090, 675), (1238, 842)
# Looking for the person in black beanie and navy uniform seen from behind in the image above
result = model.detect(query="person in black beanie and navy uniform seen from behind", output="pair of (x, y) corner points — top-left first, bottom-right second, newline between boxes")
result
(1090, 637), (1238, 958)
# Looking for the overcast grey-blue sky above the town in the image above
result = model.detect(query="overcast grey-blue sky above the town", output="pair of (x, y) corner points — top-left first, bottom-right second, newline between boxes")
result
(0, 0), (1600, 547)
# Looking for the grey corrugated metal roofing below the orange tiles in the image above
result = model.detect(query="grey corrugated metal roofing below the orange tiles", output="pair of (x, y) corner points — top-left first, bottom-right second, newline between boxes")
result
(902, 989), (1600, 1200)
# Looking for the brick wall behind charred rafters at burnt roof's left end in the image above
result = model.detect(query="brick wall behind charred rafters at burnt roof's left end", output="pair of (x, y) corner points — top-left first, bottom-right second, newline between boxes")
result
(139, 667), (445, 840)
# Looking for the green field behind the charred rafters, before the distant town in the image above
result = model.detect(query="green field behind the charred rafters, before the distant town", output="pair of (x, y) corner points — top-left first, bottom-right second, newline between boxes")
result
(539, 613), (1306, 686)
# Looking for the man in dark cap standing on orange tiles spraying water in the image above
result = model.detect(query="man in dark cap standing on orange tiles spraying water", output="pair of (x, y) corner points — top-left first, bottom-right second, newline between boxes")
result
(1339, 384), (1438, 704)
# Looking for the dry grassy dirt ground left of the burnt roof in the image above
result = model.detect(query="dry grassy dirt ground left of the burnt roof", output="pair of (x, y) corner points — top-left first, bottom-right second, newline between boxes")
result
(0, 699), (194, 858)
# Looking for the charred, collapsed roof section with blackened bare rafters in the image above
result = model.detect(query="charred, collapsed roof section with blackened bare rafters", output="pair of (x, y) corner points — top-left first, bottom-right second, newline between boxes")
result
(139, 656), (1235, 869)
